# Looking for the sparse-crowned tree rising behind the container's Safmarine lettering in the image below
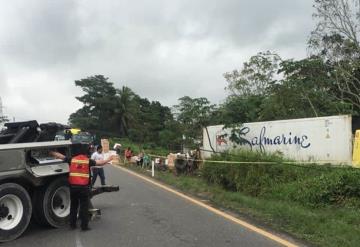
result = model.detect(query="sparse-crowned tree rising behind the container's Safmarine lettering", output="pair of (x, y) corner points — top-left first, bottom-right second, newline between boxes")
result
(219, 51), (282, 125)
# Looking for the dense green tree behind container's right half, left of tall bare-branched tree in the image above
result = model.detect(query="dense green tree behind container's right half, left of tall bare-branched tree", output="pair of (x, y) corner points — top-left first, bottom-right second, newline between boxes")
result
(261, 57), (350, 120)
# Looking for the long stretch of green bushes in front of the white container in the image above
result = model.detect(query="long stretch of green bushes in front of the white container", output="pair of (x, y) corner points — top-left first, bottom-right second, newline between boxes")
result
(202, 152), (360, 207)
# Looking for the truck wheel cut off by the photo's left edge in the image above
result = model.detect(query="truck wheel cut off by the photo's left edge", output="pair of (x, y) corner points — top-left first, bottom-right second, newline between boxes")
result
(0, 183), (32, 242)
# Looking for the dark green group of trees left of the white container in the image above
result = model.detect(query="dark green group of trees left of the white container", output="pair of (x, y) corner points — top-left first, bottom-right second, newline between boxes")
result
(69, 75), (225, 149)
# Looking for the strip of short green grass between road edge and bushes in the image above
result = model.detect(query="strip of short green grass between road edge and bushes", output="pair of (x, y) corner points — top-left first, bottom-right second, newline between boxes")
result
(122, 164), (360, 247)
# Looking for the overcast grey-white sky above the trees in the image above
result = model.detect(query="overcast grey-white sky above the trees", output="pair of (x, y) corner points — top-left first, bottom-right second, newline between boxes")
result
(0, 0), (314, 123)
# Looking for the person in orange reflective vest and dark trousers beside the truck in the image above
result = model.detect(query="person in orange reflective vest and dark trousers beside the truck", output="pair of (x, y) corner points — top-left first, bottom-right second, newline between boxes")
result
(50, 144), (113, 231)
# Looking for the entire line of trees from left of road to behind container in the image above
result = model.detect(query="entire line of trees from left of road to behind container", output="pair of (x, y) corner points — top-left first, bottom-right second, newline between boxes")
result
(69, 0), (360, 147)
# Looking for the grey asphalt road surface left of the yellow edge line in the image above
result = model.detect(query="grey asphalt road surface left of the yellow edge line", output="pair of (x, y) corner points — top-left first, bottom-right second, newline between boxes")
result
(1, 166), (292, 247)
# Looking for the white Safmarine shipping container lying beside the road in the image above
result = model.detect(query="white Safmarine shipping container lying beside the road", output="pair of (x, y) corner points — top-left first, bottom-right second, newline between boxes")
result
(203, 115), (352, 165)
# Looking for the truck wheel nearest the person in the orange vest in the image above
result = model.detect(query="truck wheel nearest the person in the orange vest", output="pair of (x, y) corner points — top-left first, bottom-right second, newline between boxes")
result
(34, 177), (70, 228)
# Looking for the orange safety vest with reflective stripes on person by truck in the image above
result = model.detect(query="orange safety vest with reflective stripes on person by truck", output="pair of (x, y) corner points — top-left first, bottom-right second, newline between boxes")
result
(69, 155), (90, 186)
